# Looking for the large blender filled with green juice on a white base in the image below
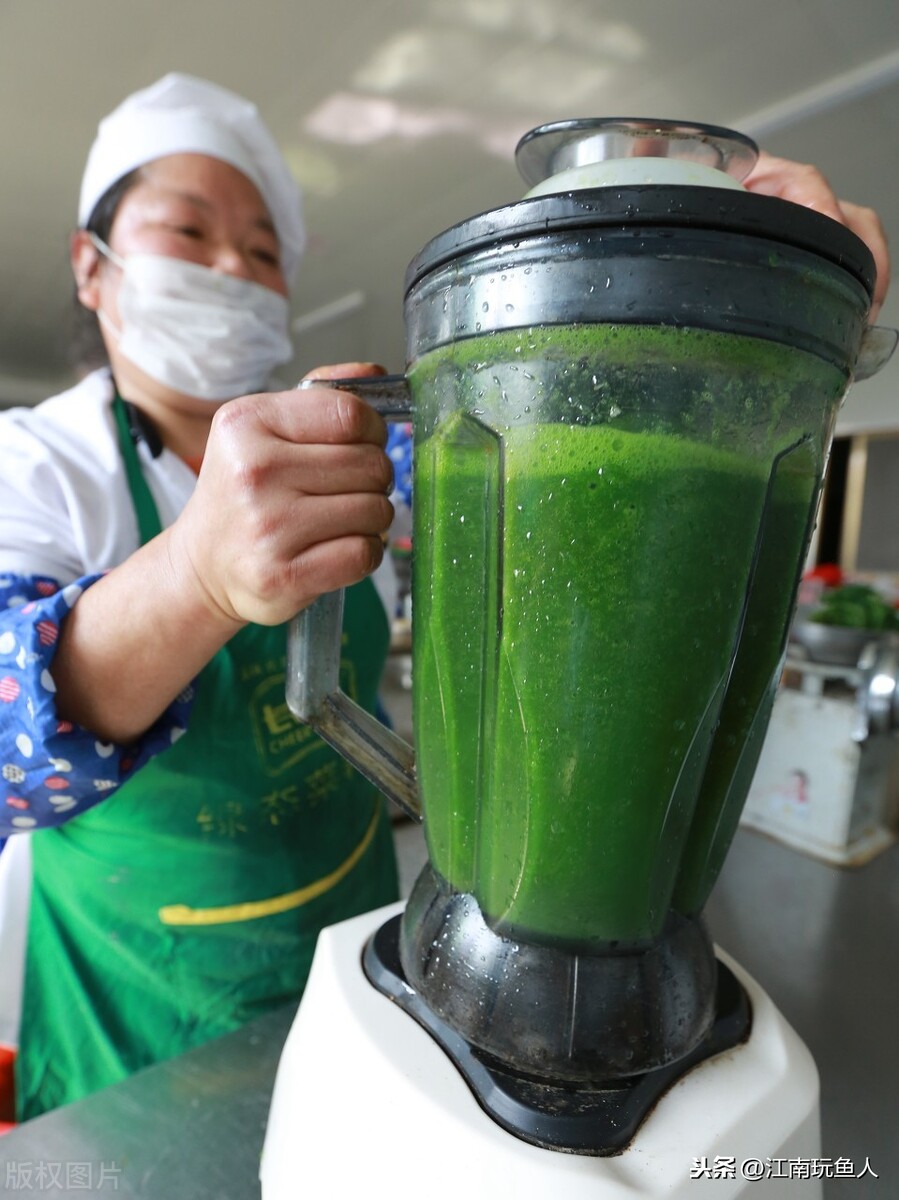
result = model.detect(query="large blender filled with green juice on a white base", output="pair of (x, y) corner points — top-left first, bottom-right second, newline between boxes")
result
(262, 119), (894, 1200)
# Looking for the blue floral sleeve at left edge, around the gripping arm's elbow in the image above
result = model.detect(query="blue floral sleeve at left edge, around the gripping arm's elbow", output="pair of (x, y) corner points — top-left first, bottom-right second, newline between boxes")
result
(0, 572), (194, 844)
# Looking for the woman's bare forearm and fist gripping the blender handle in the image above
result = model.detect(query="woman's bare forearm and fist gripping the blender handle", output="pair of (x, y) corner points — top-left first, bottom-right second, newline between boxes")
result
(53, 364), (394, 743)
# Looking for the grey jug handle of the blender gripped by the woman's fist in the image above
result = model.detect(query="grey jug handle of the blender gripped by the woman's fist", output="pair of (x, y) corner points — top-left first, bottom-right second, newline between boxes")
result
(286, 376), (421, 821)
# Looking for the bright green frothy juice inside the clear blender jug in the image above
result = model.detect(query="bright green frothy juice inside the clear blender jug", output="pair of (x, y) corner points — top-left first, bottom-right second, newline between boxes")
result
(413, 328), (841, 944)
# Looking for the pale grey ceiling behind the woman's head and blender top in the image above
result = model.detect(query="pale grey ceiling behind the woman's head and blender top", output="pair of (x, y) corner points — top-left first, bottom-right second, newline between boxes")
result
(0, 0), (899, 404)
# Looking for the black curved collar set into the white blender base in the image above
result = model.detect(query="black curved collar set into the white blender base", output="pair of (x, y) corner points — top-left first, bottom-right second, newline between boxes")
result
(362, 916), (751, 1156)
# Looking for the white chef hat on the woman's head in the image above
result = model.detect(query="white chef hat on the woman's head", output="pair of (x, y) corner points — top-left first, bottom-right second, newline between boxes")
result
(78, 73), (306, 280)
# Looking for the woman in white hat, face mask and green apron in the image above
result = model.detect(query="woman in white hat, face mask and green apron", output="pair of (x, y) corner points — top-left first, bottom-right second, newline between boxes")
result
(0, 77), (396, 1118)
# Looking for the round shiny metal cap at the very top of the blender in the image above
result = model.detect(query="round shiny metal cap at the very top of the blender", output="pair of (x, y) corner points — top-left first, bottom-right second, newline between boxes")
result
(515, 116), (759, 187)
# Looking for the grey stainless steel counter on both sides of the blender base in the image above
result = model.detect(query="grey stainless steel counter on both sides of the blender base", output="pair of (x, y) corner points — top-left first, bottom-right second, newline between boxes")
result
(0, 823), (899, 1200)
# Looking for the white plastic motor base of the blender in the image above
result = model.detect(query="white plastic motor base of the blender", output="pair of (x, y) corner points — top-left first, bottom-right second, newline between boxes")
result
(260, 904), (821, 1200)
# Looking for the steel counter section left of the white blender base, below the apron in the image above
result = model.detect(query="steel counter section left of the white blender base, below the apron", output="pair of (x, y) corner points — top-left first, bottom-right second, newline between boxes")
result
(0, 1004), (296, 1200)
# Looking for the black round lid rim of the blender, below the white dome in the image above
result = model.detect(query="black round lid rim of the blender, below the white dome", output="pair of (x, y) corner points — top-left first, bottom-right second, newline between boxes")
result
(404, 184), (876, 299)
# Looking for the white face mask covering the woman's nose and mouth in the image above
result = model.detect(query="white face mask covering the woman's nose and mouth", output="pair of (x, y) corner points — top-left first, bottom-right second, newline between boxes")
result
(91, 234), (293, 401)
